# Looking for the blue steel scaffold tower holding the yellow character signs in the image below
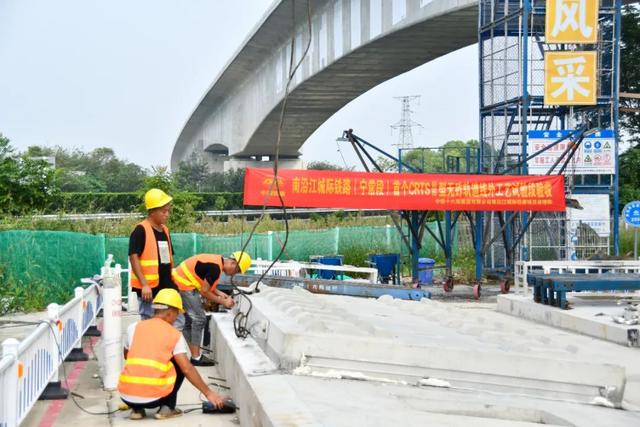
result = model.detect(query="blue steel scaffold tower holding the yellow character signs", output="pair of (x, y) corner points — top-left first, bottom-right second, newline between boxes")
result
(474, 0), (621, 279)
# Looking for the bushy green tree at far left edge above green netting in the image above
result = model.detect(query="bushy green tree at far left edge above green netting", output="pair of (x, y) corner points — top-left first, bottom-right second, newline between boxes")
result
(0, 134), (56, 214)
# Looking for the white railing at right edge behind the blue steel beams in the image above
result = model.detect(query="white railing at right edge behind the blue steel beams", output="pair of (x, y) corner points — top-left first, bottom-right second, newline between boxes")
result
(513, 260), (640, 295)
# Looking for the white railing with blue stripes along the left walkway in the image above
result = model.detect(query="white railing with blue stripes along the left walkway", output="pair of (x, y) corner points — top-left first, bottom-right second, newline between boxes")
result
(0, 283), (102, 427)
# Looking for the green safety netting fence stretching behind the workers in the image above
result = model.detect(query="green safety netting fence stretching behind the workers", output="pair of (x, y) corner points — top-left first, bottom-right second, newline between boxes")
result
(0, 223), (457, 292)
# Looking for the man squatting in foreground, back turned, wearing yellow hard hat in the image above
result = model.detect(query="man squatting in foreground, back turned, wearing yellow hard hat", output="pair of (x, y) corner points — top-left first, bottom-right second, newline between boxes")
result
(118, 289), (224, 420)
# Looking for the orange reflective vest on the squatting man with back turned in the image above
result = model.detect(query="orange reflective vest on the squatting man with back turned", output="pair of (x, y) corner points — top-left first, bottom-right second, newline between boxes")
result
(118, 317), (180, 400)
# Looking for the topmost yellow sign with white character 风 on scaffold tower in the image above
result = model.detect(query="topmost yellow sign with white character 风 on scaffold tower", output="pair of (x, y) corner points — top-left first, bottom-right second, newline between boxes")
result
(545, 0), (598, 43)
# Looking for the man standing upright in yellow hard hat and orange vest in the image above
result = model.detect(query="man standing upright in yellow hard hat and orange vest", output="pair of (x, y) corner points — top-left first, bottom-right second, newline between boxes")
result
(129, 188), (176, 320)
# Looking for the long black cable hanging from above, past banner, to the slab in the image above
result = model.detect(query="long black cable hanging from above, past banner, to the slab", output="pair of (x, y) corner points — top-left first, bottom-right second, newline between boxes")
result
(230, 0), (312, 339)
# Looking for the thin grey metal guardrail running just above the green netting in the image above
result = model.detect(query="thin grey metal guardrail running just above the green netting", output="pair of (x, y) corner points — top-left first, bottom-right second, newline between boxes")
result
(30, 208), (386, 222)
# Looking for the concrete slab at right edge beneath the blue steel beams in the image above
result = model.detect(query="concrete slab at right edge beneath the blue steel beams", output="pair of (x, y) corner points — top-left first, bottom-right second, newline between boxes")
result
(497, 294), (640, 347)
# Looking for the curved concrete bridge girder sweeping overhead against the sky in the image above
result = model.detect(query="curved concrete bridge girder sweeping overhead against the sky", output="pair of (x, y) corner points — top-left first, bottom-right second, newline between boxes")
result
(171, 0), (477, 169)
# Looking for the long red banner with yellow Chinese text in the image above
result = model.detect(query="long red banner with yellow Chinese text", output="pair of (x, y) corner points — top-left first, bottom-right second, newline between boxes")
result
(244, 168), (565, 211)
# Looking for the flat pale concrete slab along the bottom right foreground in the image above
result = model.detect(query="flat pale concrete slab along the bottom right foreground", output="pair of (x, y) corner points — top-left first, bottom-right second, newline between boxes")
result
(285, 376), (639, 427)
